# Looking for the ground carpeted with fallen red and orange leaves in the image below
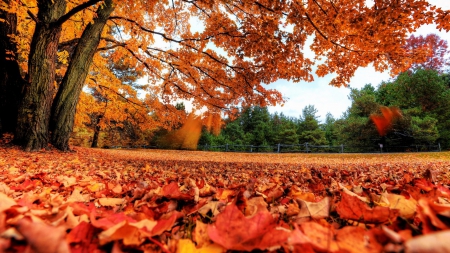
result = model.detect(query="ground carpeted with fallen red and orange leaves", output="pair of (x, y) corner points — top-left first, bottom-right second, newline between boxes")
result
(0, 139), (450, 253)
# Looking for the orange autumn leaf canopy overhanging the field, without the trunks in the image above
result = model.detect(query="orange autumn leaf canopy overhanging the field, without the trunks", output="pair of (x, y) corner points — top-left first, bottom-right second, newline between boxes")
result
(2, 0), (450, 116)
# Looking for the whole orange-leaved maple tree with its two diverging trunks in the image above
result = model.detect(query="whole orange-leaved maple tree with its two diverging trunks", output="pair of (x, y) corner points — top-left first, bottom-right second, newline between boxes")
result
(2, 0), (449, 150)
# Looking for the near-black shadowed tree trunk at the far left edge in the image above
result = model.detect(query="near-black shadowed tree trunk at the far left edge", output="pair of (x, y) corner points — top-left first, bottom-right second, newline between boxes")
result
(0, 0), (25, 134)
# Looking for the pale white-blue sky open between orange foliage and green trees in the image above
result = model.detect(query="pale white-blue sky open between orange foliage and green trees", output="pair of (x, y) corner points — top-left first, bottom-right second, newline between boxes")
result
(266, 0), (450, 122)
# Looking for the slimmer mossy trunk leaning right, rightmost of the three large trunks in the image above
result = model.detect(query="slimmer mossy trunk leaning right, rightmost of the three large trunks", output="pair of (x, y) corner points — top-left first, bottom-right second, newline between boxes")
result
(50, 0), (114, 150)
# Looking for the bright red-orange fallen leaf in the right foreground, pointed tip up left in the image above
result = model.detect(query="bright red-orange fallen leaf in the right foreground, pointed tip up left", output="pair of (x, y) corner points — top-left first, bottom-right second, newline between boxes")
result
(336, 192), (399, 223)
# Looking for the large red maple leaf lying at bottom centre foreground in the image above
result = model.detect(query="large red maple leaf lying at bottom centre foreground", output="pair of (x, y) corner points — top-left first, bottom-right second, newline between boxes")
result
(208, 204), (290, 251)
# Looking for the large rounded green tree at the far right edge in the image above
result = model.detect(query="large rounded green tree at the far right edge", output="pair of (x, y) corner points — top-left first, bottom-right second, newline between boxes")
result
(377, 69), (450, 148)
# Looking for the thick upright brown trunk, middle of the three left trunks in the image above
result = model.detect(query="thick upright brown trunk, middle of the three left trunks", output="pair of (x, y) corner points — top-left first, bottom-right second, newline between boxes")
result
(14, 0), (66, 151)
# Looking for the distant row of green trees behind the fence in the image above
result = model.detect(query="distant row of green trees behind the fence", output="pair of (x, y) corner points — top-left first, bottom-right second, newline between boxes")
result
(199, 68), (450, 151)
